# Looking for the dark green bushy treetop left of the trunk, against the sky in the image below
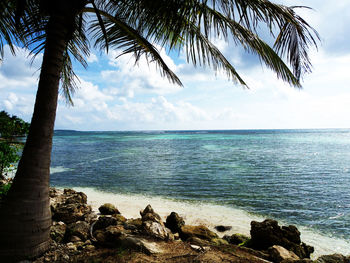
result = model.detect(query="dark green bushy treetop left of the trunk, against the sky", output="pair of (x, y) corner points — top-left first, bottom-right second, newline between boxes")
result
(0, 111), (30, 139)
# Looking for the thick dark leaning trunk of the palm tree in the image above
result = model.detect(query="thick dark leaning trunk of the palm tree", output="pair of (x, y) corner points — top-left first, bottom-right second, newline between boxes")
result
(0, 12), (73, 262)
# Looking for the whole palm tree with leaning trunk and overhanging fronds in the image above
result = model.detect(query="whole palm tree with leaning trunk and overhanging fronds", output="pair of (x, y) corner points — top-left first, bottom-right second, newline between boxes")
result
(0, 0), (318, 260)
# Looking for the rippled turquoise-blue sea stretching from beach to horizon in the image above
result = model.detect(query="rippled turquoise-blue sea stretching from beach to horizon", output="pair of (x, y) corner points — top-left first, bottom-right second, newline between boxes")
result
(51, 130), (350, 239)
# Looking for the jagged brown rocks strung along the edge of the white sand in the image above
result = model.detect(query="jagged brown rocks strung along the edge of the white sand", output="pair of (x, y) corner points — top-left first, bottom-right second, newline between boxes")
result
(32, 188), (350, 263)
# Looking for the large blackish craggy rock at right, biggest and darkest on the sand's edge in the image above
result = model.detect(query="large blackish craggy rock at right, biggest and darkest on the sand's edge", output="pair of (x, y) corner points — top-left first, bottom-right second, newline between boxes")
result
(249, 219), (314, 258)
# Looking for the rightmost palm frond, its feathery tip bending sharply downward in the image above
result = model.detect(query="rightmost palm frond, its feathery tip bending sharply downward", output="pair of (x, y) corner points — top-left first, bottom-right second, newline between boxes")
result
(208, 0), (320, 81)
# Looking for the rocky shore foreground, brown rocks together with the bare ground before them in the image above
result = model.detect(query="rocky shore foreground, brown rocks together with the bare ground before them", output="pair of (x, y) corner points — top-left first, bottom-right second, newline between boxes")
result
(21, 188), (350, 263)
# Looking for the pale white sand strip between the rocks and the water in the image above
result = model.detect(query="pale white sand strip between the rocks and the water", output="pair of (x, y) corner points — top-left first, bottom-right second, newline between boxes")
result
(74, 188), (350, 258)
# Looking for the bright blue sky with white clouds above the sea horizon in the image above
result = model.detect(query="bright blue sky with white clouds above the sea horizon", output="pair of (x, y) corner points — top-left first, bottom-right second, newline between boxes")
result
(0, 0), (350, 131)
